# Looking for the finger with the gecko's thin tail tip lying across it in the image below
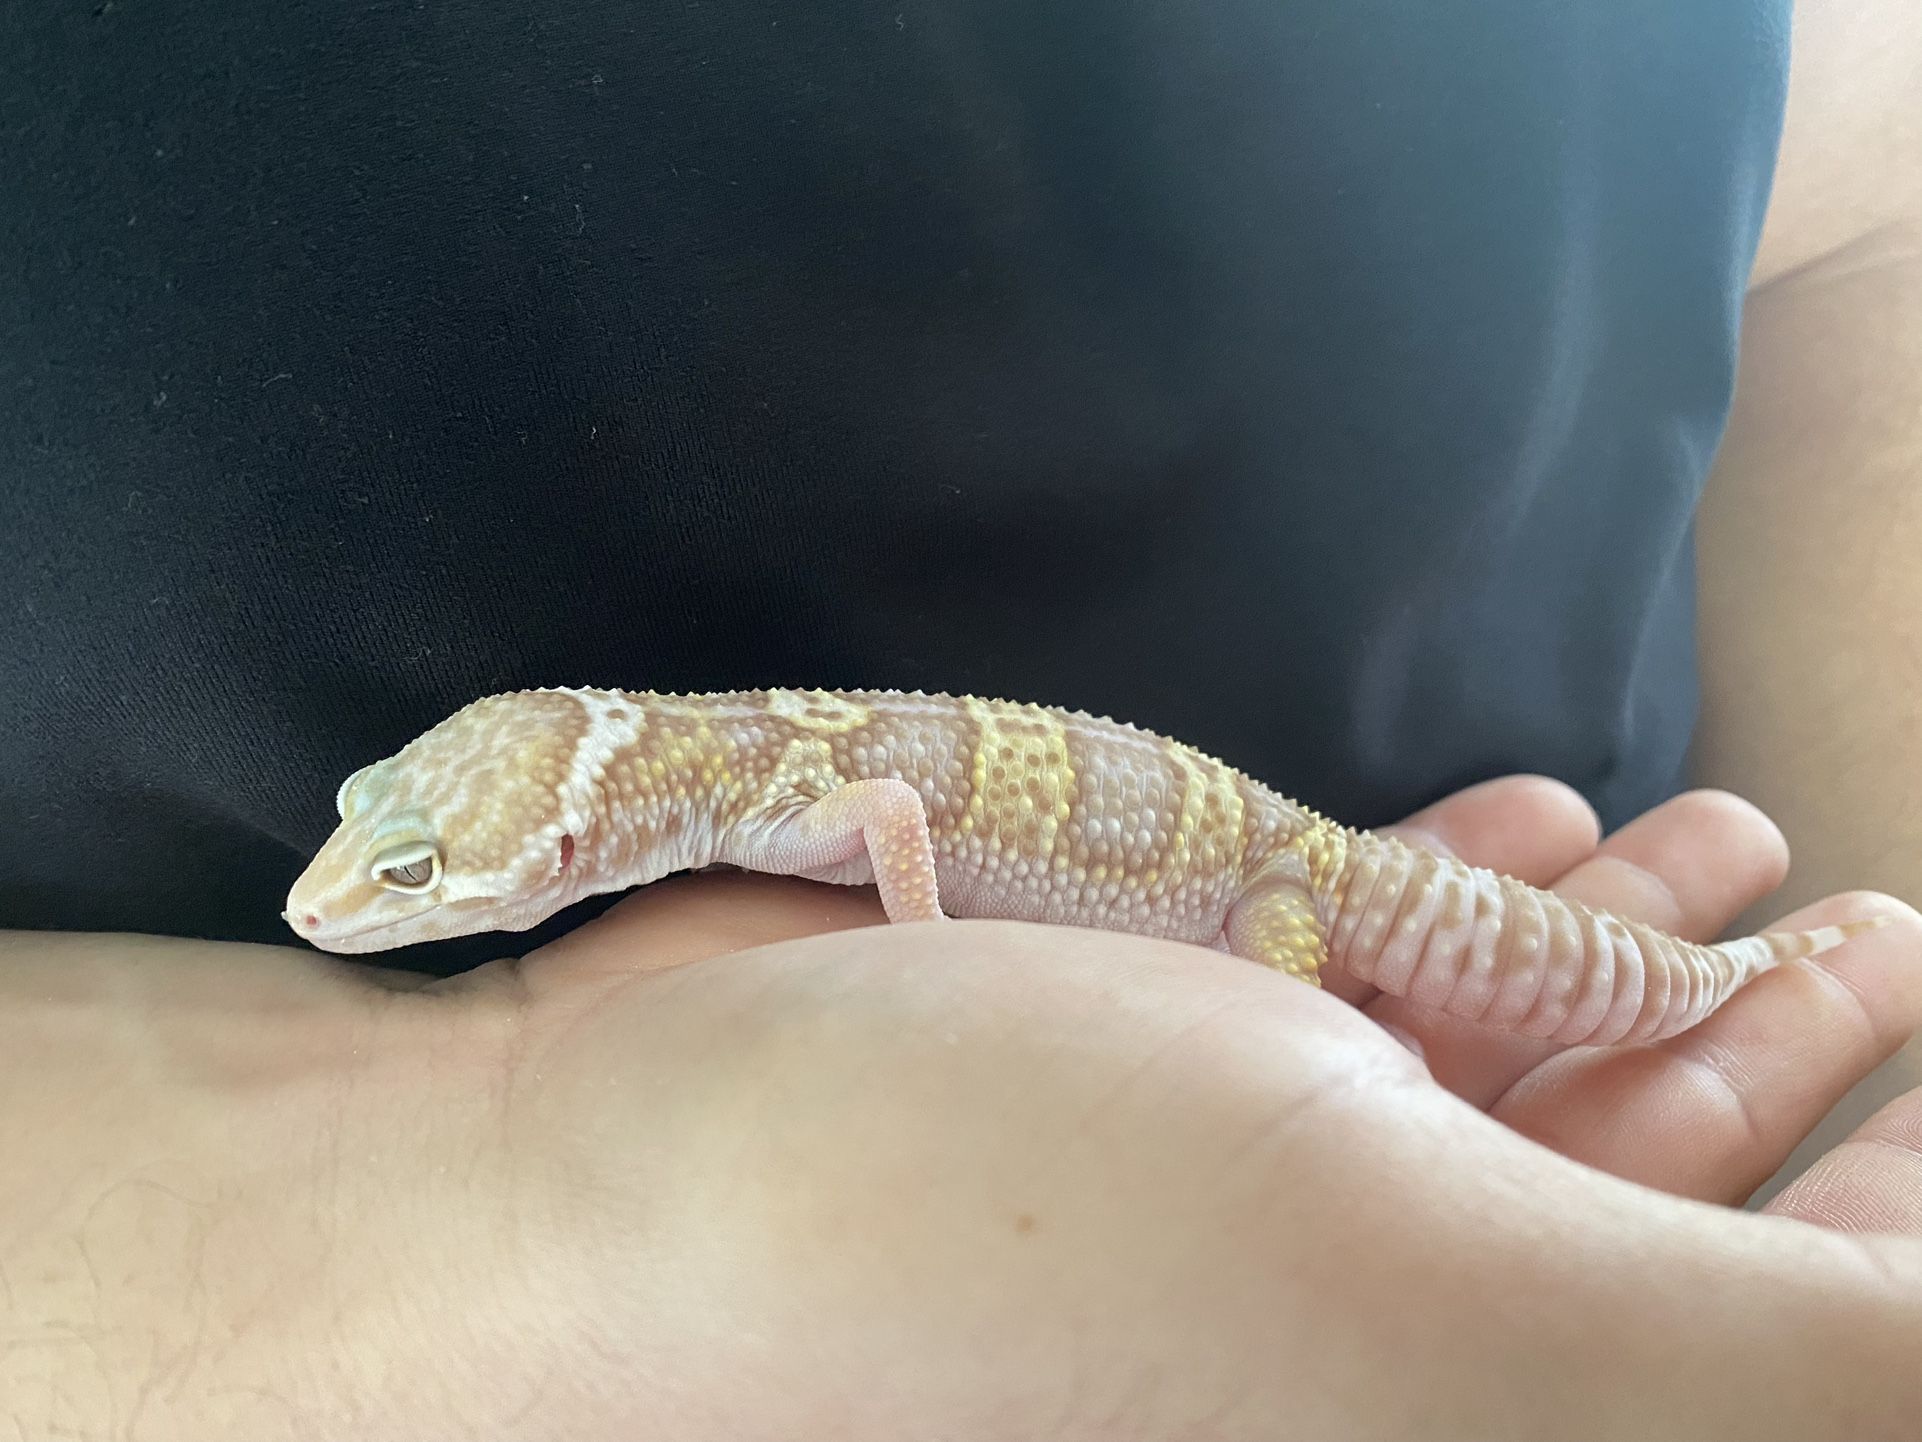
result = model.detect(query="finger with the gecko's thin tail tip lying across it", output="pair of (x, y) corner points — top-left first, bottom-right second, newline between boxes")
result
(1493, 892), (1922, 1204)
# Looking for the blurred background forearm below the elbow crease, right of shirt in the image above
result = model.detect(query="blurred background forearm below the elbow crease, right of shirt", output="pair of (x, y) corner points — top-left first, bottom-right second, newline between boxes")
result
(1695, 227), (1922, 925)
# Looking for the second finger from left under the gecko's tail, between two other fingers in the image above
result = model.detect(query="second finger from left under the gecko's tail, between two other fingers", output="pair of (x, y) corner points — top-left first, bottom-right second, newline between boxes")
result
(1368, 790), (1787, 1106)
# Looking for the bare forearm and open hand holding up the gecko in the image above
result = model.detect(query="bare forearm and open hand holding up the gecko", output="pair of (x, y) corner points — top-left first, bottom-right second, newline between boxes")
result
(0, 779), (1922, 1442)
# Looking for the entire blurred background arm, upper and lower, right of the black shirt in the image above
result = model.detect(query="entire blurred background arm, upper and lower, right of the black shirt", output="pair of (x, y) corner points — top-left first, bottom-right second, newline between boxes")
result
(1693, 0), (1922, 1175)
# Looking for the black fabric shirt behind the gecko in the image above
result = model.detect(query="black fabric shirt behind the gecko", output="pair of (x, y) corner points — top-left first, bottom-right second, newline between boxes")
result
(0, 0), (1787, 969)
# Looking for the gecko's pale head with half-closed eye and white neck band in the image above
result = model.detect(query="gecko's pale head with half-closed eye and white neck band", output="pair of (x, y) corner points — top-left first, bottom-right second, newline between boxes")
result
(283, 690), (598, 952)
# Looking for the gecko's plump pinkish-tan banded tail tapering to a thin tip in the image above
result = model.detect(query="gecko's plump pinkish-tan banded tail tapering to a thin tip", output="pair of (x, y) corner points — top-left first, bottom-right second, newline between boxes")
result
(1313, 833), (1885, 1046)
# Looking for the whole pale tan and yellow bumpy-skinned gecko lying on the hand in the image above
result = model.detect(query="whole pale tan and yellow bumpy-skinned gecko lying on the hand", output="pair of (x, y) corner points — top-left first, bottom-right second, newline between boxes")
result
(286, 688), (1878, 1046)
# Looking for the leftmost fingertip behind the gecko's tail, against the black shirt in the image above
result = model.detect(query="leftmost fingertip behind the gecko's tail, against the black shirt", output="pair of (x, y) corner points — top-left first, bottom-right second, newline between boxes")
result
(1324, 775), (1601, 1006)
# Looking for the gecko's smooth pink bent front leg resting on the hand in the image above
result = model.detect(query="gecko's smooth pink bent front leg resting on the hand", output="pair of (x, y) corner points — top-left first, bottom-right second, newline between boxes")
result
(728, 777), (942, 921)
